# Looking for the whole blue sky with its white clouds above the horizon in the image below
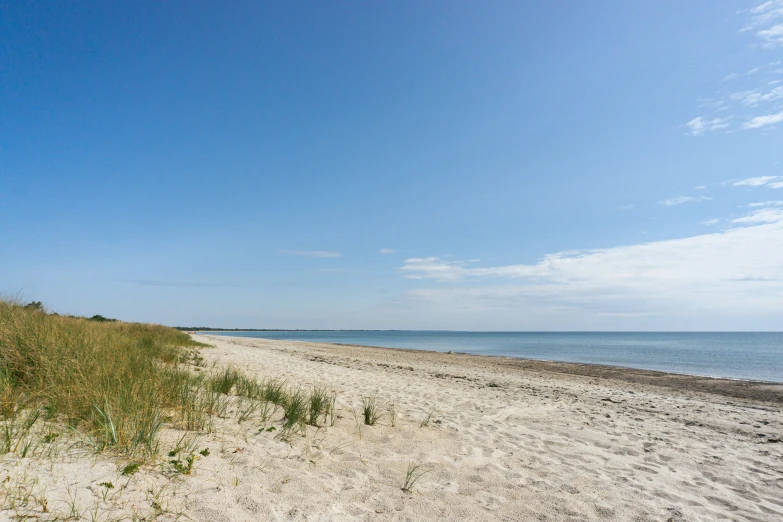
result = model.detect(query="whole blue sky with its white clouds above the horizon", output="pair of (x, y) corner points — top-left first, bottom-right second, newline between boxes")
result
(0, 0), (783, 331)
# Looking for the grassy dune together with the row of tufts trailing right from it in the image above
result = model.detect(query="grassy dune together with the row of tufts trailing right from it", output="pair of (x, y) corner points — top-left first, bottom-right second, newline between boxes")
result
(0, 300), (350, 459)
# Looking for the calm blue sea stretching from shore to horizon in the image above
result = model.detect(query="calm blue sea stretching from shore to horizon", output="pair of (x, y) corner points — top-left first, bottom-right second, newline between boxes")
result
(207, 331), (783, 382)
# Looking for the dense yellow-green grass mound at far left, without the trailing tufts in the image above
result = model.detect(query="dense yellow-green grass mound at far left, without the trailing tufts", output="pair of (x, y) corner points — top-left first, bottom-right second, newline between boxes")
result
(0, 301), (210, 453)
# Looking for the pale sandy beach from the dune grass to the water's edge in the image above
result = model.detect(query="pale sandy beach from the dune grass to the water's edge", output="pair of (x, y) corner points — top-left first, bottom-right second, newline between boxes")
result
(0, 335), (783, 521)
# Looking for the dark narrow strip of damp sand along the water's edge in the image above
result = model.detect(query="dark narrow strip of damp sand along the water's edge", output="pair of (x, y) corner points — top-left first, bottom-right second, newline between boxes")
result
(208, 333), (783, 404)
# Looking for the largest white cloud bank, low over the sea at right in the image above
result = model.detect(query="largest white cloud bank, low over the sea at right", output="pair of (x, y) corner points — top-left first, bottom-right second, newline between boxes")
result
(400, 209), (783, 320)
